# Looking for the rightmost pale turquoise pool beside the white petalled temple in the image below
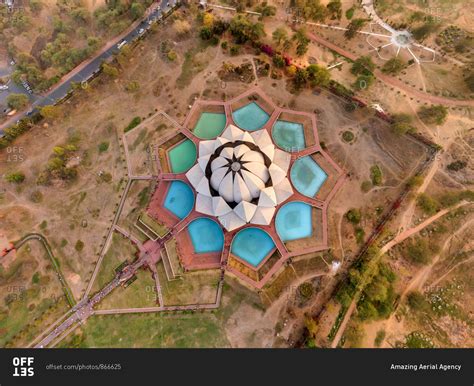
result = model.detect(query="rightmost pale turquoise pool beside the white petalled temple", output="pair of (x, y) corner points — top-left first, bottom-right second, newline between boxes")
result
(290, 156), (328, 197)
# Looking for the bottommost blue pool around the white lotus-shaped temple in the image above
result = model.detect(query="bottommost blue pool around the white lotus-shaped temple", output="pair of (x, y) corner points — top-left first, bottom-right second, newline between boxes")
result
(231, 228), (275, 267)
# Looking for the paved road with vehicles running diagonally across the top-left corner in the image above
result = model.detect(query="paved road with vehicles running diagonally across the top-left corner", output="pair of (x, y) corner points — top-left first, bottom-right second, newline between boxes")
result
(0, 0), (179, 137)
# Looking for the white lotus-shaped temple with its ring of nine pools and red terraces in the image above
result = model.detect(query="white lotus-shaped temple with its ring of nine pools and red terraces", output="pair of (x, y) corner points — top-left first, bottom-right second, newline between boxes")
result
(147, 88), (343, 288)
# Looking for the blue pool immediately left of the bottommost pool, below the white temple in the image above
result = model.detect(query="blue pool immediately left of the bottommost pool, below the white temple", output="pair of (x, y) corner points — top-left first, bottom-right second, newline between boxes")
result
(188, 217), (224, 253)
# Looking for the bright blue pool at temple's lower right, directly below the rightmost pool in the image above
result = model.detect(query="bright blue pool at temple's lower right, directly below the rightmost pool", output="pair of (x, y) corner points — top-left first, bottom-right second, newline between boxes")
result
(275, 202), (313, 241)
